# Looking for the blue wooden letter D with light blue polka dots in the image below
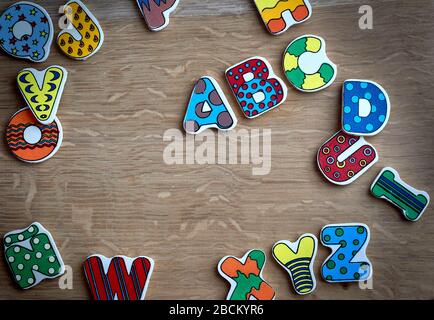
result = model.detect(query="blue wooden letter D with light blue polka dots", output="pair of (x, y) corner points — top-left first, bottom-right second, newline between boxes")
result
(342, 80), (390, 136)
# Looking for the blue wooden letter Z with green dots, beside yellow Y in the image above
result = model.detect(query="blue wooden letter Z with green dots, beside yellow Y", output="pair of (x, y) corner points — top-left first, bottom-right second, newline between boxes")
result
(321, 225), (372, 282)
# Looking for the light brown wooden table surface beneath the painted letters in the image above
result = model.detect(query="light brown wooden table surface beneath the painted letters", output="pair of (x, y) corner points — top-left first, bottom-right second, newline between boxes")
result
(0, 0), (434, 299)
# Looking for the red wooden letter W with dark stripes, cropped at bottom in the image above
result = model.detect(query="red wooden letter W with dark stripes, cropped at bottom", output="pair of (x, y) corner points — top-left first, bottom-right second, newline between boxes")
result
(84, 255), (153, 300)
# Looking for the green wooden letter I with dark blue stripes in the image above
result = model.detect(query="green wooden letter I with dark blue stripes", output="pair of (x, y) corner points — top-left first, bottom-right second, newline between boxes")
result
(371, 168), (429, 221)
